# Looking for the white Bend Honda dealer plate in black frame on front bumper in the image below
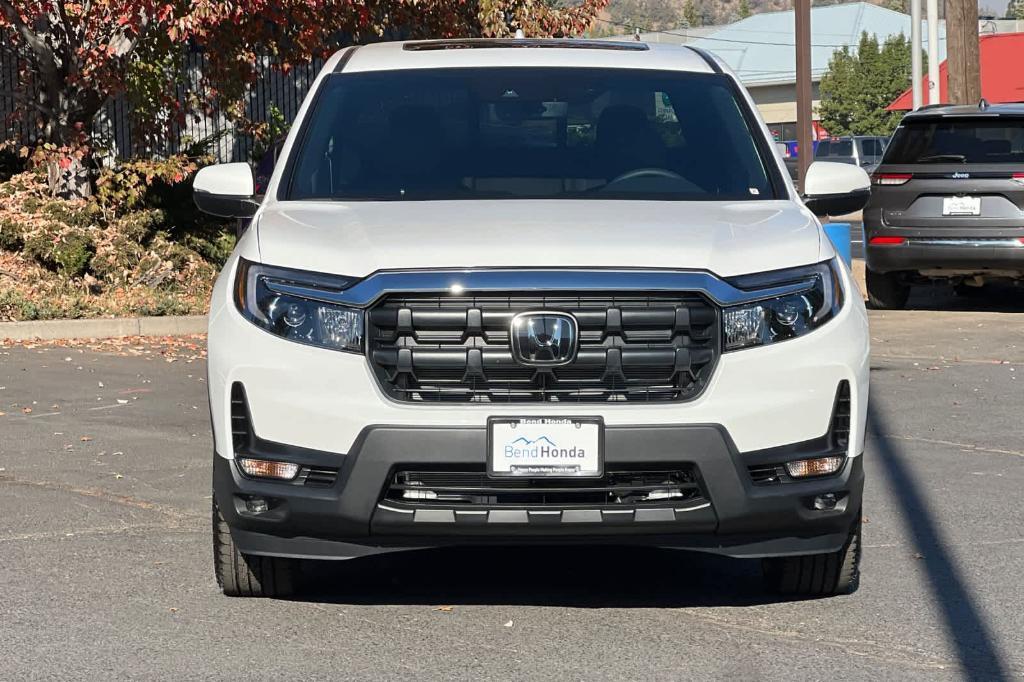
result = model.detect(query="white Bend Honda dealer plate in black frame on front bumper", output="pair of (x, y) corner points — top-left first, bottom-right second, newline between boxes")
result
(487, 417), (604, 478)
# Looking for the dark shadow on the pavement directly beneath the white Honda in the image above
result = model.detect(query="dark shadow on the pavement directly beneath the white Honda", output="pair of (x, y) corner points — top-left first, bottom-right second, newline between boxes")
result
(302, 546), (780, 608)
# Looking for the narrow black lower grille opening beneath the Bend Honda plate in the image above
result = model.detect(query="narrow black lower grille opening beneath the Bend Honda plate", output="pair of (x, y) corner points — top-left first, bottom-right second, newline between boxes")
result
(384, 465), (703, 508)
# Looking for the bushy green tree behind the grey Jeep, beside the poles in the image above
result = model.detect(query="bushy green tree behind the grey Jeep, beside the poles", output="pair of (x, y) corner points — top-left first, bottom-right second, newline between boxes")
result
(818, 33), (911, 135)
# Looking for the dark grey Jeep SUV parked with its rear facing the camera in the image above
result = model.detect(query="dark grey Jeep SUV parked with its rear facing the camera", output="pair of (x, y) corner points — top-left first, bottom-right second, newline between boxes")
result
(864, 100), (1024, 308)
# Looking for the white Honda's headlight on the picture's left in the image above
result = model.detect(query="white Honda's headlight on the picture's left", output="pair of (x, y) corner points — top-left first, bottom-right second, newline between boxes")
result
(234, 254), (364, 353)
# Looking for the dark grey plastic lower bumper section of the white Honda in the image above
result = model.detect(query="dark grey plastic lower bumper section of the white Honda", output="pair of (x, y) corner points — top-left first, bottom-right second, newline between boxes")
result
(214, 425), (863, 559)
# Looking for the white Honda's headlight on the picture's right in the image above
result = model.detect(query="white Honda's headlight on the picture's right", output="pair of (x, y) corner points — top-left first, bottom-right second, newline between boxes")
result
(722, 256), (843, 350)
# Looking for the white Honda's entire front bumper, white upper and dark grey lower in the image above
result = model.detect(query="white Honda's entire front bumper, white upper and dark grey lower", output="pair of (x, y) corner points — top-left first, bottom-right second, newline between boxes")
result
(209, 249), (869, 558)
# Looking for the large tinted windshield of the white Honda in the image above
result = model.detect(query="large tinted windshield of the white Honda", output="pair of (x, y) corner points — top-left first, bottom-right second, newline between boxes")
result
(285, 68), (774, 201)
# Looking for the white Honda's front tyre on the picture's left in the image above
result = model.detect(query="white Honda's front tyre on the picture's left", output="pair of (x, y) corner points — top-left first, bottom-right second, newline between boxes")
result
(213, 499), (299, 597)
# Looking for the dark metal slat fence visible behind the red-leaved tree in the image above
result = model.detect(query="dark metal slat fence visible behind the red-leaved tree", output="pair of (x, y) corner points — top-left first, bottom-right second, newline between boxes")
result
(0, 48), (324, 162)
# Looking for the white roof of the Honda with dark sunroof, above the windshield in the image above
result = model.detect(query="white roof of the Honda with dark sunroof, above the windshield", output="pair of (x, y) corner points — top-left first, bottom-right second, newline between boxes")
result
(335, 38), (722, 74)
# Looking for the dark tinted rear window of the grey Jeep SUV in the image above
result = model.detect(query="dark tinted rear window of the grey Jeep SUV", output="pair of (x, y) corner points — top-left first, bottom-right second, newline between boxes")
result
(883, 117), (1024, 164)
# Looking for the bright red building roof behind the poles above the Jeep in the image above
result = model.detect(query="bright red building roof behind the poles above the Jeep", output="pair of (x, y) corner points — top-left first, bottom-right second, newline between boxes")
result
(887, 33), (1024, 112)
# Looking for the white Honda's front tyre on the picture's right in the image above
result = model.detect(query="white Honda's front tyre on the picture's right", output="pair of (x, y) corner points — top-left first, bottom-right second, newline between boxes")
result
(762, 519), (860, 597)
